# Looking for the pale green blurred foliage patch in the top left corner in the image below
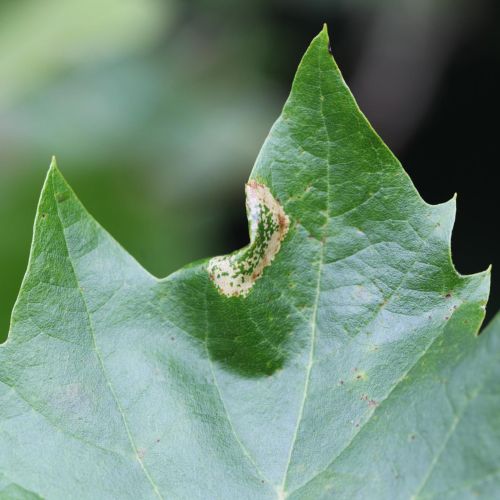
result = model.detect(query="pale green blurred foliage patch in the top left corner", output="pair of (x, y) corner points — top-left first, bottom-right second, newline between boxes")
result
(0, 0), (171, 105)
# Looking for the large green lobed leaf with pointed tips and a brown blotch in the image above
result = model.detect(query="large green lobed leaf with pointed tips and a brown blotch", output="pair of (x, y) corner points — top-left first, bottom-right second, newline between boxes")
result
(0, 30), (492, 499)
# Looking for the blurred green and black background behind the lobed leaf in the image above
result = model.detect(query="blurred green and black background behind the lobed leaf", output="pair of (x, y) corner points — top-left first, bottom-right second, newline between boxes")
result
(0, 0), (500, 340)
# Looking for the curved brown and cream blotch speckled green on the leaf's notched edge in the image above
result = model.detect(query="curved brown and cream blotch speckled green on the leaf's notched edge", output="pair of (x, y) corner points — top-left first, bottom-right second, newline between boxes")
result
(208, 180), (290, 297)
